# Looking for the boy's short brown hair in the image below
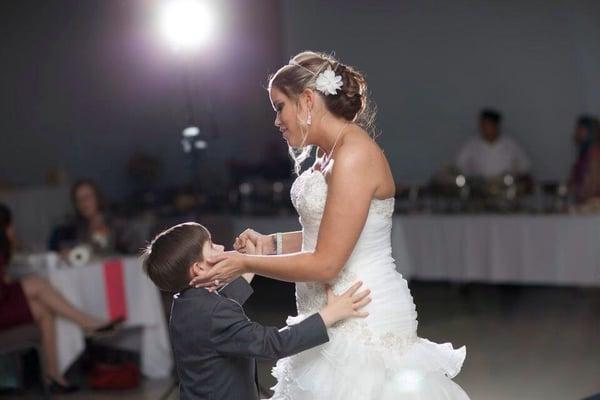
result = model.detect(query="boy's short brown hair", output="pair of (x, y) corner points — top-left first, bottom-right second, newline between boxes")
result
(142, 222), (210, 292)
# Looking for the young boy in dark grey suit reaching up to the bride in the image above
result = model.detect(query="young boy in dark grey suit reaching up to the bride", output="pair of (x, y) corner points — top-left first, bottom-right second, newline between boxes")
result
(143, 222), (370, 400)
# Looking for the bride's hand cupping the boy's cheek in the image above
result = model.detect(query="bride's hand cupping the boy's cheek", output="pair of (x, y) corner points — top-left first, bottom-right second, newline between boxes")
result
(190, 251), (248, 289)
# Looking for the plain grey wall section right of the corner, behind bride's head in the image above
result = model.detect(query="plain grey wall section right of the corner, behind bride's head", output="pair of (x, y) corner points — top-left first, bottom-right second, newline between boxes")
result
(282, 0), (600, 182)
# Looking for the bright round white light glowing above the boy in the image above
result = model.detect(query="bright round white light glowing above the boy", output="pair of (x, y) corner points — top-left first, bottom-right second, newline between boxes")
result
(159, 0), (213, 50)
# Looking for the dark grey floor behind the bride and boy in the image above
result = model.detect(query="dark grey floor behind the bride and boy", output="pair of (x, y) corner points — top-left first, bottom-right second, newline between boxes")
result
(2, 279), (600, 400)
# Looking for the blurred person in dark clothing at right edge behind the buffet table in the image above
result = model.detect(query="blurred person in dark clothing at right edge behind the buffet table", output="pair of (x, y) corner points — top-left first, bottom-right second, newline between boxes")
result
(569, 115), (600, 204)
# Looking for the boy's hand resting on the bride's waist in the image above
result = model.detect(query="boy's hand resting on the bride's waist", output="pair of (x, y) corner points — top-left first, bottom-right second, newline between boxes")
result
(319, 282), (371, 328)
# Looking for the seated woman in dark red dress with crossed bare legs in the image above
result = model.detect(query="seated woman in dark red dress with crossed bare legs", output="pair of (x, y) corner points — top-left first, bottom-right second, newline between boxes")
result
(0, 204), (120, 393)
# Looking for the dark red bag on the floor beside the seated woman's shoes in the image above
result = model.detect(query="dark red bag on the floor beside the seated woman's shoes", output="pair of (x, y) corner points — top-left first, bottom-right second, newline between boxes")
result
(88, 361), (140, 390)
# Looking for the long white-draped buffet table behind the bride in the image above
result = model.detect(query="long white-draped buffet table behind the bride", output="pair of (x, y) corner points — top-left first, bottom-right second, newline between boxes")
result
(232, 214), (600, 286)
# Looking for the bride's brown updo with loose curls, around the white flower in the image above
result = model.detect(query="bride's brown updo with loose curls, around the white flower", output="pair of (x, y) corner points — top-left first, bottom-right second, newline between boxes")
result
(269, 51), (375, 173)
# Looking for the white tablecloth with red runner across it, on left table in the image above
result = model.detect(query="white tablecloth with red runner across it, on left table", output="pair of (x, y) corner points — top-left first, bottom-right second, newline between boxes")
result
(42, 256), (173, 378)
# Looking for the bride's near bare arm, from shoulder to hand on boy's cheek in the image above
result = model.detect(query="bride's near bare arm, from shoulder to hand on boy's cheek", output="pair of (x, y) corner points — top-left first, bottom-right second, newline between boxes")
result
(193, 143), (376, 286)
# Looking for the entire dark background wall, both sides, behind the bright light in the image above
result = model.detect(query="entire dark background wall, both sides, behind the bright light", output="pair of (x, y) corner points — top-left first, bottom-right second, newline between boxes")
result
(0, 0), (600, 197)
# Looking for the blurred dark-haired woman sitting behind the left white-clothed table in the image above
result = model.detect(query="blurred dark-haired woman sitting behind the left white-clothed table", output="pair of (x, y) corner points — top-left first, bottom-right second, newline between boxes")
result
(49, 179), (134, 254)
